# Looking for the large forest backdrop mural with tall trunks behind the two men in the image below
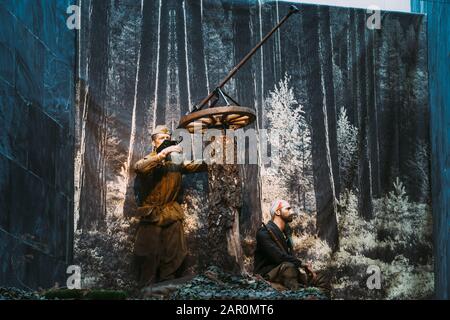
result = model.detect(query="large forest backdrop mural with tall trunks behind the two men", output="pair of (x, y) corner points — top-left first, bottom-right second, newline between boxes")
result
(74, 0), (433, 298)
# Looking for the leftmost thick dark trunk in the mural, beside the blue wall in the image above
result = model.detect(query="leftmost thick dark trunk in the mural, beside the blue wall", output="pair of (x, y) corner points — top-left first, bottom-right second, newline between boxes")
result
(78, 1), (109, 229)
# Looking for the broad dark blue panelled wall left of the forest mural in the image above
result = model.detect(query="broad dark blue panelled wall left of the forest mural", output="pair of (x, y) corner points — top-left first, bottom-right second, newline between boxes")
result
(0, 0), (75, 288)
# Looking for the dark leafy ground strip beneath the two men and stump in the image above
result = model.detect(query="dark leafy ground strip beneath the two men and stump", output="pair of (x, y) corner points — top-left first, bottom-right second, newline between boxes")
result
(0, 267), (329, 300)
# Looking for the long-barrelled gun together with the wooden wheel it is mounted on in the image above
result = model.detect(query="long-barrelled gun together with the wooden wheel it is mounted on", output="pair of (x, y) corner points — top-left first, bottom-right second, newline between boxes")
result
(178, 5), (300, 133)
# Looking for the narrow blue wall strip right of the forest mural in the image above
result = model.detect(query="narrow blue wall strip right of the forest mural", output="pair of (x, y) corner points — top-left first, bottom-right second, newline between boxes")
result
(411, 0), (450, 299)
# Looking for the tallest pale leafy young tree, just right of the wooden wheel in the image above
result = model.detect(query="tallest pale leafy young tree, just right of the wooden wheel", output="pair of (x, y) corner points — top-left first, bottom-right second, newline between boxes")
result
(261, 75), (313, 211)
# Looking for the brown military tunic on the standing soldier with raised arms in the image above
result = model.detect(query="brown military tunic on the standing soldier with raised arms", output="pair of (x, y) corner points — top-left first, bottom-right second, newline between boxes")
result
(134, 152), (207, 226)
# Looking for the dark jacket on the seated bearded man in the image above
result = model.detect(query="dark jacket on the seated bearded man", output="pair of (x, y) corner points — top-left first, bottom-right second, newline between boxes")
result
(254, 221), (301, 276)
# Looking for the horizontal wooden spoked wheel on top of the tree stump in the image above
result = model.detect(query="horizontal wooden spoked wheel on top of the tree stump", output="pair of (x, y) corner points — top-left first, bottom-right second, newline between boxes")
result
(178, 106), (256, 133)
